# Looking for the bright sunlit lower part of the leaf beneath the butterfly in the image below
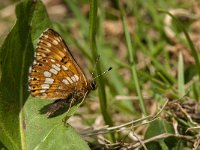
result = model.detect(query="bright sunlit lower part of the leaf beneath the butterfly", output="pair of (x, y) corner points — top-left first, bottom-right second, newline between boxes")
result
(23, 97), (89, 150)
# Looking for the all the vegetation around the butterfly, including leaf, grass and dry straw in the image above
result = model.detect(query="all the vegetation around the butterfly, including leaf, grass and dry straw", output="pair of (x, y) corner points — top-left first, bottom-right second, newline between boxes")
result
(0, 0), (200, 150)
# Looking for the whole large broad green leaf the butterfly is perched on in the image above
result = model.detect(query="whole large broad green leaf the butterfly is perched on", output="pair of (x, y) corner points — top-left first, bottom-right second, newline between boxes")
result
(0, 0), (89, 150)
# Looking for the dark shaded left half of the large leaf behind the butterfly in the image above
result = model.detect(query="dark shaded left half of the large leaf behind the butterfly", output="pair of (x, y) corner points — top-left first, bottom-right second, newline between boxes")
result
(0, 1), (35, 150)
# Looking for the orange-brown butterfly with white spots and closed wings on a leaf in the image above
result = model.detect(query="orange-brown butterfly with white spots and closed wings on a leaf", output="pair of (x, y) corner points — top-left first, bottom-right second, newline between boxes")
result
(29, 29), (100, 117)
